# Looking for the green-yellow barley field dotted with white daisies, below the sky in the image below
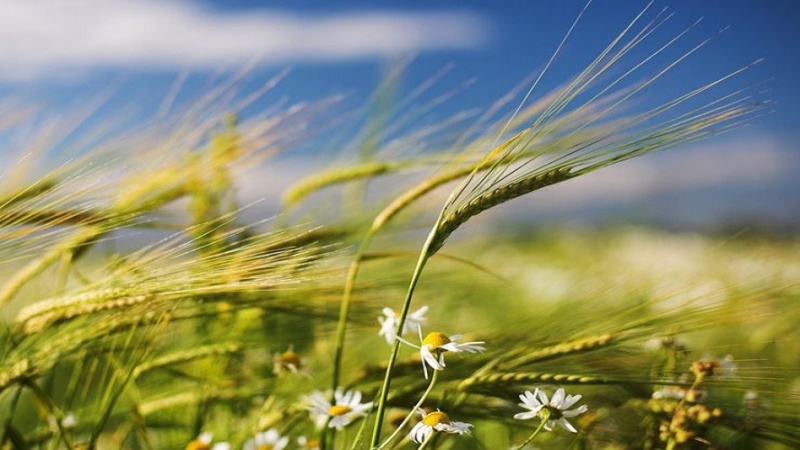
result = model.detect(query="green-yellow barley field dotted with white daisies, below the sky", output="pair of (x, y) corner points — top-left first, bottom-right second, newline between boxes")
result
(0, 4), (800, 450)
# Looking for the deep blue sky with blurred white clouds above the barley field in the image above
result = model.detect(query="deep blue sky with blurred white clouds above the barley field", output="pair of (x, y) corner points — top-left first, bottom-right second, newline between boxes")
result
(0, 0), (800, 229)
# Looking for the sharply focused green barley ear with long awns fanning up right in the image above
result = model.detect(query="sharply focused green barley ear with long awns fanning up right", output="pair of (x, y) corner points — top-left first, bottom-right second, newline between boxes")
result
(418, 5), (763, 255)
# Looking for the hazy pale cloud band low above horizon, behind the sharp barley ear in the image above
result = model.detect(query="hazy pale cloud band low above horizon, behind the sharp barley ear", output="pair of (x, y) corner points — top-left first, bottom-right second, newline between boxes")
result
(237, 134), (800, 227)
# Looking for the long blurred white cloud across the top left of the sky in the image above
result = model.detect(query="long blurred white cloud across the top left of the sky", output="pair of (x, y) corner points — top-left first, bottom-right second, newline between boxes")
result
(0, 0), (489, 79)
